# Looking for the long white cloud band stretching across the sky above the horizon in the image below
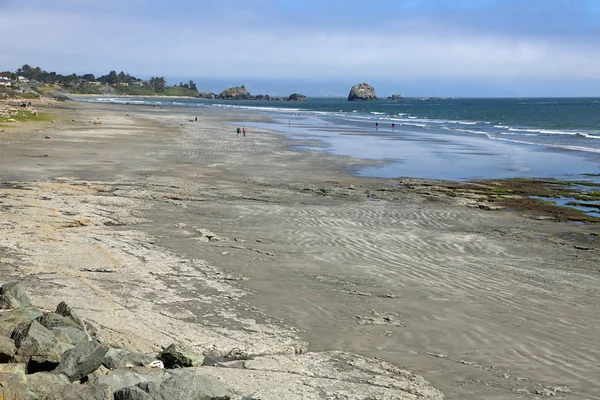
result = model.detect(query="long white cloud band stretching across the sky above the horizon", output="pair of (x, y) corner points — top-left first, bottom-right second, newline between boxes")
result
(0, 6), (600, 81)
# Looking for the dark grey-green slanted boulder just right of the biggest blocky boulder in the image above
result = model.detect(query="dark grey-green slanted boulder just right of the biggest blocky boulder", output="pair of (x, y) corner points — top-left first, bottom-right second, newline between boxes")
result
(55, 340), (108, 382)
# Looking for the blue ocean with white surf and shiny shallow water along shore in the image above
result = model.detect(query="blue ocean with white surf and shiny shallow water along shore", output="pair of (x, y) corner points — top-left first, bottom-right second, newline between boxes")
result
(77, 97), (600, 182)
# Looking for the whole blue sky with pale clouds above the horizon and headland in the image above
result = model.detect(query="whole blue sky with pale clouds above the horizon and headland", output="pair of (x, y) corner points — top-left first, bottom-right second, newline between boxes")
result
(0, 0), (600, 97)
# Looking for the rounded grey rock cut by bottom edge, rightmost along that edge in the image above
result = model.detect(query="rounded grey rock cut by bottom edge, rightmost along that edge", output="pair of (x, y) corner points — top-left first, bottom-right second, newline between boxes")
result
(139, 373), (231, 400)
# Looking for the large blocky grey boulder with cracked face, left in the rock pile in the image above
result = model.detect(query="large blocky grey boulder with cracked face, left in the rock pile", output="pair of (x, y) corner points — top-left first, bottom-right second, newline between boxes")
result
(11, 321), (72, 373)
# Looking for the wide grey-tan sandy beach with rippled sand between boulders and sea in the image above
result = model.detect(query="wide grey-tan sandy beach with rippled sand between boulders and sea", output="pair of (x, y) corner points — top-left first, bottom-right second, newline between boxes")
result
(0, 102), (600, 400)
